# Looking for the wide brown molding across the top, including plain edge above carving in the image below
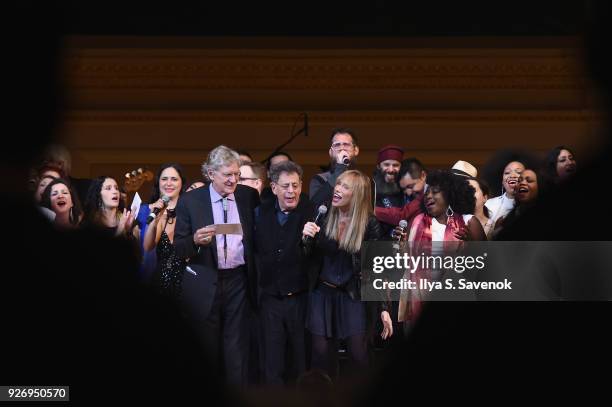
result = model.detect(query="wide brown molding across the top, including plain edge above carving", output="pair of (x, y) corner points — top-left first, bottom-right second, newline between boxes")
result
(65, 38), (584, 91)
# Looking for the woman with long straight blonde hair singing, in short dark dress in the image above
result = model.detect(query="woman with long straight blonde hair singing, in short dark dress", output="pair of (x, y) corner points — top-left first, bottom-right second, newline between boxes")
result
(303, 170), (393, 376)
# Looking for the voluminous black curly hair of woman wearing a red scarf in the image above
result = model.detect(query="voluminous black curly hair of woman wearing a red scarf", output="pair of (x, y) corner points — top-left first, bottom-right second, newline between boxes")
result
(421, 170), (476, 215)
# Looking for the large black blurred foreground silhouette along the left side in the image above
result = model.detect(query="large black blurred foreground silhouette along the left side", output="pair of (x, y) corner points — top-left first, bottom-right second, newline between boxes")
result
(0, 2), (227, 405)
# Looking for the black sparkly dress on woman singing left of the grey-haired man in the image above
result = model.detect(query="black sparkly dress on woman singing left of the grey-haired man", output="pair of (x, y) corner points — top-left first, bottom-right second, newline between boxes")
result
(155, 228), (186, 299)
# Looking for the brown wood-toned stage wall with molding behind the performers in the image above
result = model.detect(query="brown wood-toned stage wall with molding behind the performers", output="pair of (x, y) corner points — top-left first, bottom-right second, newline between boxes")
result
(60, 36), (601, 201)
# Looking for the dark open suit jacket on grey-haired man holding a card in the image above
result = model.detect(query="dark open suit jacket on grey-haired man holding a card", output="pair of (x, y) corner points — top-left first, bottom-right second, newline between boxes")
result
(174, 185), (259, 320)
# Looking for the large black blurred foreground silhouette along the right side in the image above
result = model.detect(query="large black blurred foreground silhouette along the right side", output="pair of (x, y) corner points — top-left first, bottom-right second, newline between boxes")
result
(363, 1), (612, 405)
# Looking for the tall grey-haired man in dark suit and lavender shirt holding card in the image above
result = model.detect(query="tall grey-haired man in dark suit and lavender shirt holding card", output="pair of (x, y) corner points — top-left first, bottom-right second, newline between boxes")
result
(174, 146), (259, 385)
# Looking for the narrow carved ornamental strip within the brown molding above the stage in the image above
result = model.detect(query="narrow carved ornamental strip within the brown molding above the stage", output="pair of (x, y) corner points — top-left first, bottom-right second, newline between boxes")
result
(67, 56), (584, 90)
